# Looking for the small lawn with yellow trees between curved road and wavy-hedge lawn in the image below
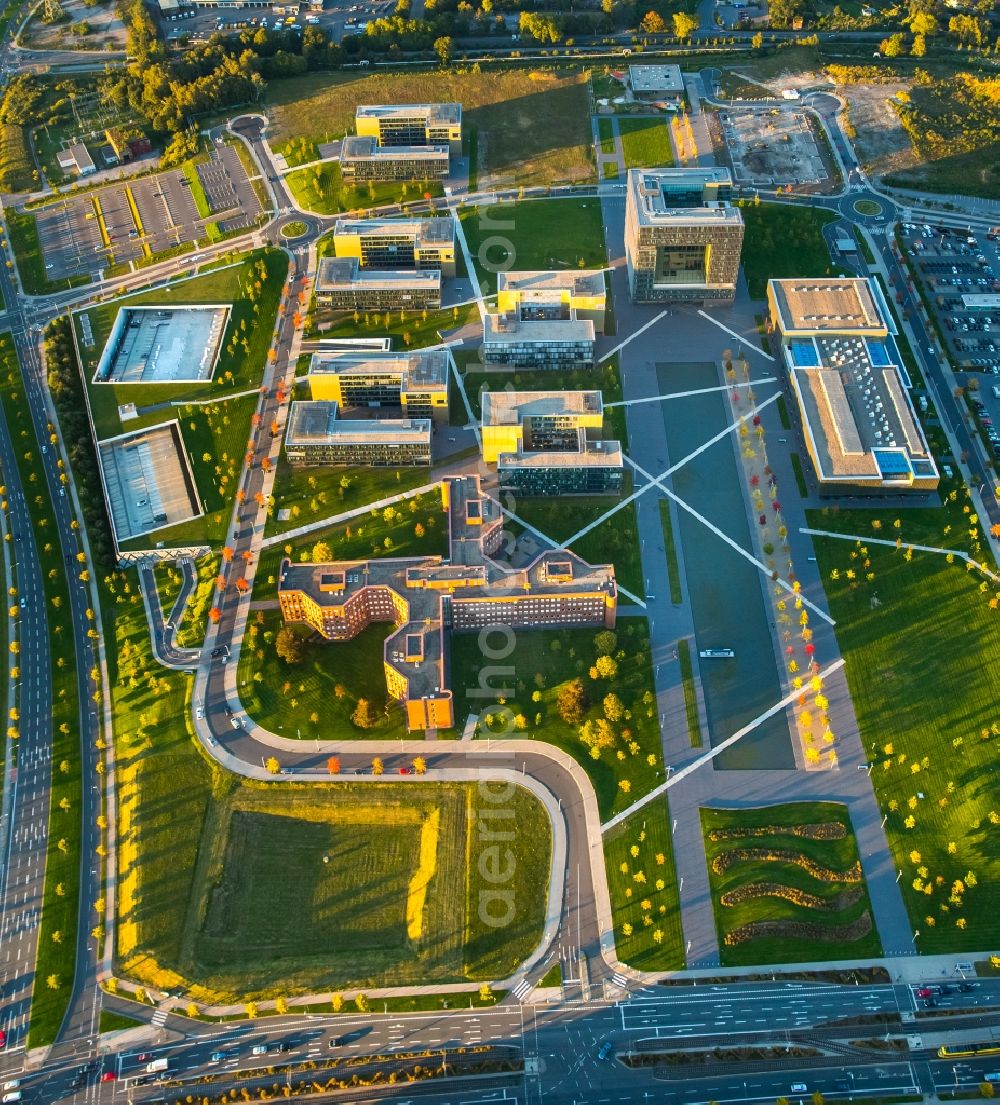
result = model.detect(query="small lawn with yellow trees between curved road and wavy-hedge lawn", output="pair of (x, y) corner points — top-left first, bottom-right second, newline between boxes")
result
(604, 798), (684, 970)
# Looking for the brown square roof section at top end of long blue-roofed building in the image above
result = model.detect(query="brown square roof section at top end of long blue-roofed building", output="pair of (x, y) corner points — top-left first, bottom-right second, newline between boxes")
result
(768, 277), (888, 334)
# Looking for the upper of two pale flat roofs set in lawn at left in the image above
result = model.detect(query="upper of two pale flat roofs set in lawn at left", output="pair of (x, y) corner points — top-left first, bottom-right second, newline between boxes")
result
(93, 305), (230, 383)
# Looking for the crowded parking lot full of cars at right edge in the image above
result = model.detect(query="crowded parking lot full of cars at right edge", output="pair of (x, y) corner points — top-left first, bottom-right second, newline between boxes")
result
(902, 223), (1000, 376)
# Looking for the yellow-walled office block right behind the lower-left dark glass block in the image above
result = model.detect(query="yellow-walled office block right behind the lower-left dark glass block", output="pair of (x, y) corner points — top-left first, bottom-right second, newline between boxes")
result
(306, 349), (449, 421)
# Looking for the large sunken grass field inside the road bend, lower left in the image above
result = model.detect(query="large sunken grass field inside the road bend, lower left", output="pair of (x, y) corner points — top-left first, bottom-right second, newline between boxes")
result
(105, 572), (550, 994)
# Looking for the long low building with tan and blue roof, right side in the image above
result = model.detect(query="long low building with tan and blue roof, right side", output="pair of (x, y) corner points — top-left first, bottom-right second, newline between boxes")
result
(767, 276), (939, 495)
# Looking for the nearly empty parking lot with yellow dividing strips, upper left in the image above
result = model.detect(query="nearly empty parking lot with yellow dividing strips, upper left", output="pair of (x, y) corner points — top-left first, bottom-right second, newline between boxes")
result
(35, 146), (261, 280)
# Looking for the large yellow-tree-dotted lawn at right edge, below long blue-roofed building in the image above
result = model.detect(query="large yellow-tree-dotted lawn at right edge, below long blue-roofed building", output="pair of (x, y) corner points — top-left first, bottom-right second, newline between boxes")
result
(808, 492), (1000, 954)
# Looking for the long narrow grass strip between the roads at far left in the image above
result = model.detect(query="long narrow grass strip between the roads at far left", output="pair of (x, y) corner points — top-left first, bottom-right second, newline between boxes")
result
(0, 334), (83, 1048)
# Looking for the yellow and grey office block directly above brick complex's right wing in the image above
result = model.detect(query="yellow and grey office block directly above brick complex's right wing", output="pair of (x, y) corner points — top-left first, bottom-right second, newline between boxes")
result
(480, 391), (624, 495)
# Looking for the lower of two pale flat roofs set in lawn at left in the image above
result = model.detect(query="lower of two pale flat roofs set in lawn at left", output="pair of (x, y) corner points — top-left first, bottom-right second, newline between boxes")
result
(97, 420), (202, 545)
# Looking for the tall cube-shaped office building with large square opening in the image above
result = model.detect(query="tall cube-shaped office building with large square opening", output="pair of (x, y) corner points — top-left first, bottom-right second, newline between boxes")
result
(625, 168), (744, 303)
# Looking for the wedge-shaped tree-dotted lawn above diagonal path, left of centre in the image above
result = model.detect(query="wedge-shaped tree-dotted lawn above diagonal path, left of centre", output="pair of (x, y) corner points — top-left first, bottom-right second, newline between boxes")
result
(266, 453), (431, 537)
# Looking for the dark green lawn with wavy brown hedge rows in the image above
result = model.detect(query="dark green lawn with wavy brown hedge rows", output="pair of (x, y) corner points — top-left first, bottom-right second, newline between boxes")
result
(702, 802), (882, 967)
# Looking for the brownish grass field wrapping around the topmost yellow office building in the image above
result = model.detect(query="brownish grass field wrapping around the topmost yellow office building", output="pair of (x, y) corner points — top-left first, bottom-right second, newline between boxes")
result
(267, 69), (594, 187)
